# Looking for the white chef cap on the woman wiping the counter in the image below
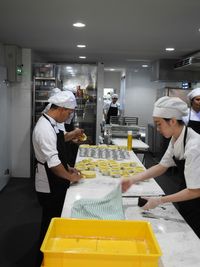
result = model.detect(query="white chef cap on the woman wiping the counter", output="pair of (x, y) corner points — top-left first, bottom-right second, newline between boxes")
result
(153, 96), (188, 120)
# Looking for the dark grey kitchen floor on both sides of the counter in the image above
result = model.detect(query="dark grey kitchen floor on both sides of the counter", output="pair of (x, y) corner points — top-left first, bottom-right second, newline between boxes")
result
(0, 153), (176, 267)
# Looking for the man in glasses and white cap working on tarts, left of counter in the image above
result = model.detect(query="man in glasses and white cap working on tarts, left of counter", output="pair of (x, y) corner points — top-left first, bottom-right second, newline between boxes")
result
(32, 91), (81, 266)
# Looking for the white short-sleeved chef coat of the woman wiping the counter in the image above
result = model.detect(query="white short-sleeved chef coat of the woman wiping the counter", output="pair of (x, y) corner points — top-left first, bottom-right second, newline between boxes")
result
(160, 126), (200, 189)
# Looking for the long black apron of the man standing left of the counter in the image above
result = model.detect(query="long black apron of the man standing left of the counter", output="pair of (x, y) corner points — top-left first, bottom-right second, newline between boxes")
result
(36, 114), (70, 267)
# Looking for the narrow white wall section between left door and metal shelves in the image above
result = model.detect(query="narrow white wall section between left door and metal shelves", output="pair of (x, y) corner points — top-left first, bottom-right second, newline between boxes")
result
(10, 49), (32, 177)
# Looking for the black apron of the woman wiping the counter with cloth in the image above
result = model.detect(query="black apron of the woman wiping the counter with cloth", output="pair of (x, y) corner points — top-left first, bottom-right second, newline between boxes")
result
(173, 127), (200, 238)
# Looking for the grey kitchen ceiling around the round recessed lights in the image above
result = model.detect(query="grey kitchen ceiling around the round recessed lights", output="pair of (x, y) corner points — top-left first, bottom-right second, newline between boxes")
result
(0, 0), (200, 65)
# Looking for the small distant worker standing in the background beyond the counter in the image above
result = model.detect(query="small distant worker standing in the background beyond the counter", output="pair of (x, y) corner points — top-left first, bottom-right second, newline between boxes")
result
(103, 94), (120, 124)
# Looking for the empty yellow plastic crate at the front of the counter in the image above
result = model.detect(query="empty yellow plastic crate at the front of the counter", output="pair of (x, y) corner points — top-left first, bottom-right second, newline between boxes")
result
(41, 218), (162, 267)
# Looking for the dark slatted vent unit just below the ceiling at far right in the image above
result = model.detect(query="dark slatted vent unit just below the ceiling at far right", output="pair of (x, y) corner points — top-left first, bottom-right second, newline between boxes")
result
(174, 52), (200, 71)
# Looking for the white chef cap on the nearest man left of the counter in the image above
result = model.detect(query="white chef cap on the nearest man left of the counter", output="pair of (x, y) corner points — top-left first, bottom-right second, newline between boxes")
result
(48, 91), (76, 109)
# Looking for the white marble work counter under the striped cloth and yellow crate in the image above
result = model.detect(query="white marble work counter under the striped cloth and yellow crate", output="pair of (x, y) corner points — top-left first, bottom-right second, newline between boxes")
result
(62, 151), (200, 267)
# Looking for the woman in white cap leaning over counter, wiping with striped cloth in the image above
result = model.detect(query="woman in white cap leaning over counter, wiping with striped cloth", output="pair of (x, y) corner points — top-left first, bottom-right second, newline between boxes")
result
(122, 96), (200, 238)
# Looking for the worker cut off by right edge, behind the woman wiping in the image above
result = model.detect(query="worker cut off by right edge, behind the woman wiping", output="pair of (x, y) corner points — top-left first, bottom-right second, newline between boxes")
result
(183, 88), (200, 134)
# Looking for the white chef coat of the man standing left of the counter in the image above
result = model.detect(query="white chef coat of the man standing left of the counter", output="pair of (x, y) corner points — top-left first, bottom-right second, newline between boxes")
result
(32, 114), (61, 193)
